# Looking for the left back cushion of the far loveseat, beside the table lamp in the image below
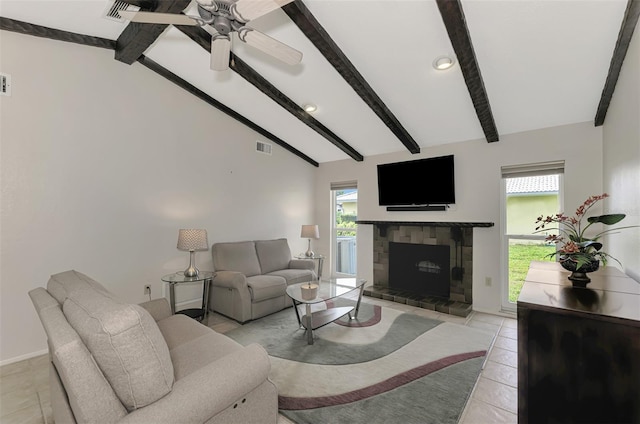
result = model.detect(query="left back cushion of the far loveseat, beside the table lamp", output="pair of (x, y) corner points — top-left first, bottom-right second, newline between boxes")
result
(211, 241), (261, 277)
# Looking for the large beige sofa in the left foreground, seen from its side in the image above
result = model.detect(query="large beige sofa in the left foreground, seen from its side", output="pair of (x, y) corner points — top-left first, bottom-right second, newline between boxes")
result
(29, 271), (278, 424)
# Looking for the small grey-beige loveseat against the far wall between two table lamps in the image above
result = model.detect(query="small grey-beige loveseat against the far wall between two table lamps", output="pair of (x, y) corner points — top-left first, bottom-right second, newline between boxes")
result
(209, 238), (317, 322)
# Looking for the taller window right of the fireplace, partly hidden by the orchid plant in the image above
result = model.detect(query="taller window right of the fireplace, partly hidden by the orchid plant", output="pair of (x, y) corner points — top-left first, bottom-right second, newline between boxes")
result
(502, 161), (564, 311)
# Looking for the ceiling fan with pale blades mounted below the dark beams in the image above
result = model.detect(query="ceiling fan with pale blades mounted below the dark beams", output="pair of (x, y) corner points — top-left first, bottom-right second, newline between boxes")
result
(118, 0), (302, 71)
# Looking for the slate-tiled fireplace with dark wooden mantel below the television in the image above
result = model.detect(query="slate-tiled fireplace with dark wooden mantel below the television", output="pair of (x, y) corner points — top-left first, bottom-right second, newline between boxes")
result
(357, 220), (494, 317)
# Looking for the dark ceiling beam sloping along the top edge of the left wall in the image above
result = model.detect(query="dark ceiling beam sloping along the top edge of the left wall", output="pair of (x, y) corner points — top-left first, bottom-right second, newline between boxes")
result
(138, 55), (319, 166)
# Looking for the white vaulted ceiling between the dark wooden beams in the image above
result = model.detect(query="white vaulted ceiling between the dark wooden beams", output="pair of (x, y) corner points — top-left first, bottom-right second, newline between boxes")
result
(0, 0), (627, 163)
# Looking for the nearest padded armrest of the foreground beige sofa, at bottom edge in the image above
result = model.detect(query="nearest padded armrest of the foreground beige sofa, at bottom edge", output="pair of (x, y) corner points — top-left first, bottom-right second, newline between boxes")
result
(120, 343), (278, 424)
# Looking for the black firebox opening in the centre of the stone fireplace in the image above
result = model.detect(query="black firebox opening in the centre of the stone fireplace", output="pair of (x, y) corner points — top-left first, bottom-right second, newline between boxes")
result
(389, 242), (450, 299)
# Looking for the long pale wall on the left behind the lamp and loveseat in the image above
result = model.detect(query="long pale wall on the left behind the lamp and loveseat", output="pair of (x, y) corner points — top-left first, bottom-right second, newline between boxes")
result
(0, 31), (317, 364)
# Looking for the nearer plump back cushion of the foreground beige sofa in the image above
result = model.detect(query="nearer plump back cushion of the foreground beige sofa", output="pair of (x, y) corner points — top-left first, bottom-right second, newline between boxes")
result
(63, 288), (174, 411)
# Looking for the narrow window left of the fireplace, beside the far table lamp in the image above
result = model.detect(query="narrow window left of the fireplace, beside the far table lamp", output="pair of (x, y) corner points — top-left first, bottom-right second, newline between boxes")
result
(331, 182), (358, 277)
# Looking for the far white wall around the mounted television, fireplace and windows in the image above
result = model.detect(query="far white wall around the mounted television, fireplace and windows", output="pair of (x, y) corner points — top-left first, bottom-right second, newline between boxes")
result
(315, 122), (602, 313)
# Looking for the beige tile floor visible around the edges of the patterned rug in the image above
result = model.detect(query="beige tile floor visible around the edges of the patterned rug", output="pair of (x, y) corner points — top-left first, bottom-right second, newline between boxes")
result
(0, 297), (518, 424)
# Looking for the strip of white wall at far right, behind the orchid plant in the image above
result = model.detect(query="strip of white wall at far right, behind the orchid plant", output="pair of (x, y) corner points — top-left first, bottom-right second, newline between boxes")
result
(603, 30), (640, 282)
